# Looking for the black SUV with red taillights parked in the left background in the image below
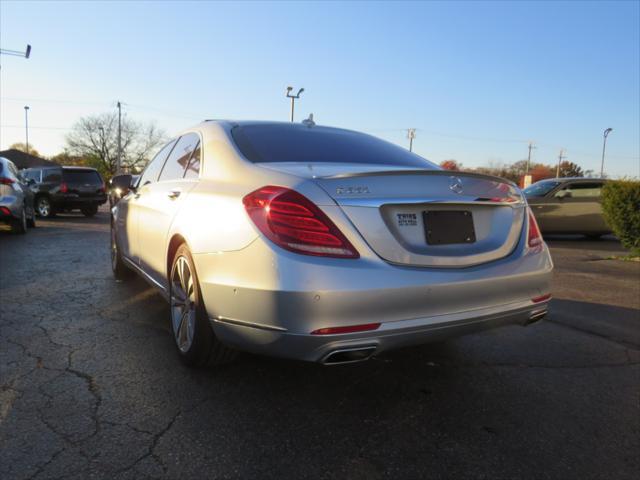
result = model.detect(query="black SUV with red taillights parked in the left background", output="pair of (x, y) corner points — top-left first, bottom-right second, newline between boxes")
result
(23, 167), (107, 217)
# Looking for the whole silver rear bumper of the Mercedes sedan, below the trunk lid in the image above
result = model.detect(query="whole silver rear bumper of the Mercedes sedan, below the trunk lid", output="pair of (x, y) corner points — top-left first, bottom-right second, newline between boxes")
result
(193, 227), (553, 361)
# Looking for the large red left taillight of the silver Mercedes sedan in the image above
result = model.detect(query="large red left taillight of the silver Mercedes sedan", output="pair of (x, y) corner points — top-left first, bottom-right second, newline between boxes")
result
(242, 186), (360, 258)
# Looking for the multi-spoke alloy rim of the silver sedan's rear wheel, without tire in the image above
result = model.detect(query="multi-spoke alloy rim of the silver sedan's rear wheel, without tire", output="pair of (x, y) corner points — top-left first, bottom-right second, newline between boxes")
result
(171, 256), (196, 353)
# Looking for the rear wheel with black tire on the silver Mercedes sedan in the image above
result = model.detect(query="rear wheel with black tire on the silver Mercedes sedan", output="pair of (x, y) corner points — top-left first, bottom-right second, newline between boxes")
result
(169, 244), (237, 367)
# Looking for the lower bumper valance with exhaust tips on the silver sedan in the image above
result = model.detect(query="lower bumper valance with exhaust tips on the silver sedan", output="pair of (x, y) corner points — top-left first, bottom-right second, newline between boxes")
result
(211, 301), (547, 362)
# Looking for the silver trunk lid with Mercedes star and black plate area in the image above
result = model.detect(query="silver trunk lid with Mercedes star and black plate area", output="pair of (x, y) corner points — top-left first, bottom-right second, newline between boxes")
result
(258, 162), (526, 267)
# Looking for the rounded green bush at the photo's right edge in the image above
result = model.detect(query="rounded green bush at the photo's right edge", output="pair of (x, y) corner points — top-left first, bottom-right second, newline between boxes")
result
(602, 180), (640, 255)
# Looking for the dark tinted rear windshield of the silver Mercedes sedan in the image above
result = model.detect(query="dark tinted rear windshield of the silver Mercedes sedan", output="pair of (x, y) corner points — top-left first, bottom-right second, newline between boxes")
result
(231, 124), (437, 169)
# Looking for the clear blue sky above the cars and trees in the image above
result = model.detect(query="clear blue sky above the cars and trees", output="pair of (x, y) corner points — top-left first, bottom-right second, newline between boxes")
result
(0, 0), (640, 176)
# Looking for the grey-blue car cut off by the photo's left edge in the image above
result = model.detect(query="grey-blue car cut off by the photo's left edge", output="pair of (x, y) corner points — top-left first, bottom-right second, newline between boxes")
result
(0, 157), (36, 233)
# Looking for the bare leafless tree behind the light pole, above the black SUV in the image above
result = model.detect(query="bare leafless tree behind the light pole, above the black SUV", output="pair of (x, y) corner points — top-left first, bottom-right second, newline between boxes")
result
(65, 113), (165, 176)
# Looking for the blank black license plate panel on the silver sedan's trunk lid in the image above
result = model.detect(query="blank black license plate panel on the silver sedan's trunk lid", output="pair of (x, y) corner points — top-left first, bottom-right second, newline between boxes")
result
(422, 210), (476, 245)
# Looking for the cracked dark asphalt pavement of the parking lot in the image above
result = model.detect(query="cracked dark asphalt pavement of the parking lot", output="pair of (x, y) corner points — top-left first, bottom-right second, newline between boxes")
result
(0, 211), (640, 480)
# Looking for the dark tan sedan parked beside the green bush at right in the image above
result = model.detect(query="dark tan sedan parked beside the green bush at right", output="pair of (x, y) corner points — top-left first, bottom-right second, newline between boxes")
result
(524, 178), (611, 238)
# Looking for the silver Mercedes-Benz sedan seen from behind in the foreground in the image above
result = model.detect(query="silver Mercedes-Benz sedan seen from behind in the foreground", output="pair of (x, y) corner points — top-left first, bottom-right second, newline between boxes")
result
(111, 121), (553, 365)
